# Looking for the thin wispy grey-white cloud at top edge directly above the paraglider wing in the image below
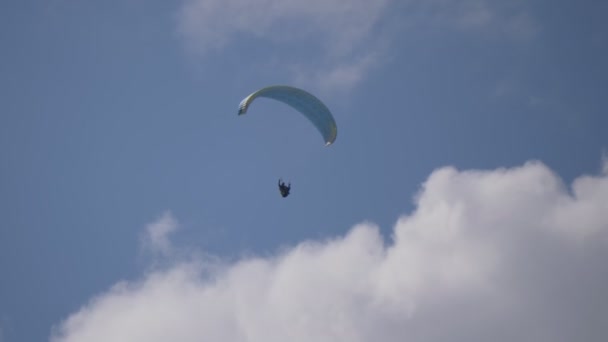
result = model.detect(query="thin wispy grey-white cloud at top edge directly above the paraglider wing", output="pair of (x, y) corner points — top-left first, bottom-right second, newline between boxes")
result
(178, 0), (389, 89)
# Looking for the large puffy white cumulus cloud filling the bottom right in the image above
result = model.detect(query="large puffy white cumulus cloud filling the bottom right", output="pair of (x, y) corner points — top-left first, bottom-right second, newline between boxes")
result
(51, 162), (608, 342)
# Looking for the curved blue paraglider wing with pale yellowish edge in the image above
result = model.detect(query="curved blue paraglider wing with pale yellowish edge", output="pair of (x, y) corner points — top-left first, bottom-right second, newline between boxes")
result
(239, 85), (338, 146)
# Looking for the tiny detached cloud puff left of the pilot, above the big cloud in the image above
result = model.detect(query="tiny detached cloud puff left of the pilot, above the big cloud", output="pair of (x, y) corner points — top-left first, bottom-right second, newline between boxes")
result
(142, 211), (179, 256)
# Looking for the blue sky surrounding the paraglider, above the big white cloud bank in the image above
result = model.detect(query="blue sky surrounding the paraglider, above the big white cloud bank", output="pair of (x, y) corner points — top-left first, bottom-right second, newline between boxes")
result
(0, 0), (608, 342)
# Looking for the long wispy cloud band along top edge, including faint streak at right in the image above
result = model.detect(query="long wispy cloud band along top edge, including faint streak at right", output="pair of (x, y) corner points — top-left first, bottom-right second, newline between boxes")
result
(177, 0), (539, 91)
